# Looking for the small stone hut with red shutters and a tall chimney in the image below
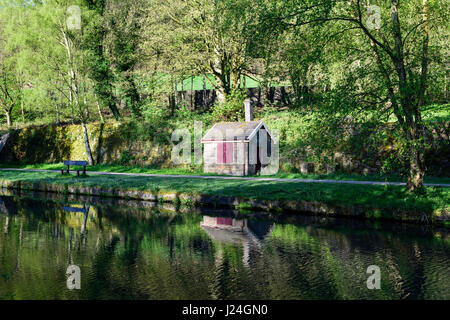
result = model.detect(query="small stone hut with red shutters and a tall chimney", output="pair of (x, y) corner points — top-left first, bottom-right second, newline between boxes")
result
(201, 101), (275, 176)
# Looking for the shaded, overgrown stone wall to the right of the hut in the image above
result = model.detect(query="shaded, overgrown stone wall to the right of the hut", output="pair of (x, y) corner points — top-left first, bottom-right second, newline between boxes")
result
(280, 122), (450, 177)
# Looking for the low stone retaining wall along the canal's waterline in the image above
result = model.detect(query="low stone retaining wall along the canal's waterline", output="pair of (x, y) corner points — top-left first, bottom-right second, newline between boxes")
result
(0, 180), (450, 225)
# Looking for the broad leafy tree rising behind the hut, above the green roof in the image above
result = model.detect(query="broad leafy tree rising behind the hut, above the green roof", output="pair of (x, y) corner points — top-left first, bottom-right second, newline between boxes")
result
(142, 0), (260, 99)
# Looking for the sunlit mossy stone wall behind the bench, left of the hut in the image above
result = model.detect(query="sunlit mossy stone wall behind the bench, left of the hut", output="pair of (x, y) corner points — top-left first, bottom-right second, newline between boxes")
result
(0, 123), (172, 167)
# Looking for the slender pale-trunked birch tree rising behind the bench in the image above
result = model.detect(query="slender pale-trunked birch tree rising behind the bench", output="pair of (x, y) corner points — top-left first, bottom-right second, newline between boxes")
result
(20, 0), (94, 165)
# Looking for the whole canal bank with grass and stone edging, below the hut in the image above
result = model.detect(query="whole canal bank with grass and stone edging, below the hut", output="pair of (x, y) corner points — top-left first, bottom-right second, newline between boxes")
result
(0, 168), (450, 225)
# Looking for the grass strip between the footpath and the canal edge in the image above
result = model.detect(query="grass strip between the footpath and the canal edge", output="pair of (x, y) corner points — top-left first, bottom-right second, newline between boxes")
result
(0, 171), (450, 212)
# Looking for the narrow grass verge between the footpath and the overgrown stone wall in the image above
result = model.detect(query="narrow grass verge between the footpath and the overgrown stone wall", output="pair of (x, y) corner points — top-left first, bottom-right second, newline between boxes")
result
(0, 163), (450, 184)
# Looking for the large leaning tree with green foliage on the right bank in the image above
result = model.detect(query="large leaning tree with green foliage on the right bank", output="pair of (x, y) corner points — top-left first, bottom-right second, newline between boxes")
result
(252, 0), (449, 190)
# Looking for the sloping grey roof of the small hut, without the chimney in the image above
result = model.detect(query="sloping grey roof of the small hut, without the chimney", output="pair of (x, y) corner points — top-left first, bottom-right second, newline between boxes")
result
(201, 121), (273, 142)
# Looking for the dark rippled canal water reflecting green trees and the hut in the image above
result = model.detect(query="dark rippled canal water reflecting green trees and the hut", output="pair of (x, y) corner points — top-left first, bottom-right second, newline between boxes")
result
(0, 191), (450, 300)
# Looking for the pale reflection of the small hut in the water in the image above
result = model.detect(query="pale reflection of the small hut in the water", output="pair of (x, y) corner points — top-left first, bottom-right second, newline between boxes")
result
(200, 216), (273, 267)
